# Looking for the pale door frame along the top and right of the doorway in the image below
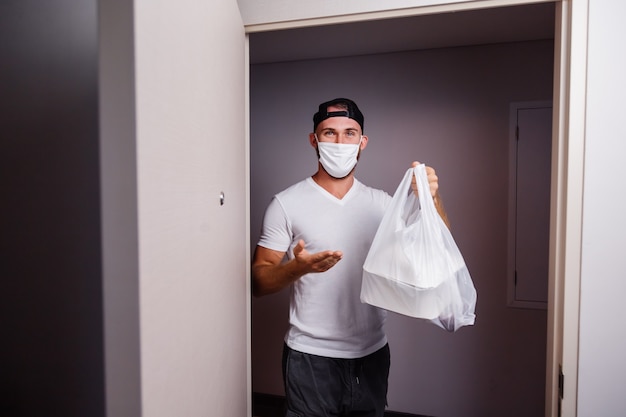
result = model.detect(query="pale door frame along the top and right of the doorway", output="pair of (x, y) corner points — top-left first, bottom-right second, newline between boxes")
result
(244, 0), (589, 417)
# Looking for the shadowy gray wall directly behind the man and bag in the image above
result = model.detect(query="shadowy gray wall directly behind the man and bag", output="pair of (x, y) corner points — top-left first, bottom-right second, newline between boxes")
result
(250, 41), (553, 417)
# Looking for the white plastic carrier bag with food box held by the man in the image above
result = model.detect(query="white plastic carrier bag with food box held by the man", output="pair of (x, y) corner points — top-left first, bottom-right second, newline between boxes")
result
(361, 164), (476, 331)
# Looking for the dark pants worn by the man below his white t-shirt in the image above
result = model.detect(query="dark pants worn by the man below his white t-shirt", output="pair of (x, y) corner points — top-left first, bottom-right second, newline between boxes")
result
(283, 345), (390, 417)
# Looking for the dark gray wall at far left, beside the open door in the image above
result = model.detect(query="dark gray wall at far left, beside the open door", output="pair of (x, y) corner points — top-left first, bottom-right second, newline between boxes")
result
(0, 0), (104, 417)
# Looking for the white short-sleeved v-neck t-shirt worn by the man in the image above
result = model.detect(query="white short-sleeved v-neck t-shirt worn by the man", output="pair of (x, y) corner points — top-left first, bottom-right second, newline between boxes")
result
(259, 177), (391, 358)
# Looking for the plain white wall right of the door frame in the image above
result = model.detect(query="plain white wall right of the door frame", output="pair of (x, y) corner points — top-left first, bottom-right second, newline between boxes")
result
(576, 0), (626, 417)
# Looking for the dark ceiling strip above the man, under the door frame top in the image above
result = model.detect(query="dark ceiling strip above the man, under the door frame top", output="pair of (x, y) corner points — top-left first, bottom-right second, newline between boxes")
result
(250, 2), (554, 64)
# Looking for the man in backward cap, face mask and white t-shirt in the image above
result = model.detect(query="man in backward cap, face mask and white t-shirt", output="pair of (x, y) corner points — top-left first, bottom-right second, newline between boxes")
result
(252, 98), (445, 417)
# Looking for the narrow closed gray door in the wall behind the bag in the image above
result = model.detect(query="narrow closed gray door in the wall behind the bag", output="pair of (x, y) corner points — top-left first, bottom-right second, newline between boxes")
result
(508, 102), (552, 309)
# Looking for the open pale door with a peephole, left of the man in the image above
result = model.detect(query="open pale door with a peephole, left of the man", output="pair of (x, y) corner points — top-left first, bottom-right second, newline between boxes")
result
(101, 0), (250, 417)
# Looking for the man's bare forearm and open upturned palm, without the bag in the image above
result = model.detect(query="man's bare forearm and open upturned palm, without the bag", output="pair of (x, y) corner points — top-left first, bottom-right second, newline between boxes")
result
(252, 240), (343, 297)
